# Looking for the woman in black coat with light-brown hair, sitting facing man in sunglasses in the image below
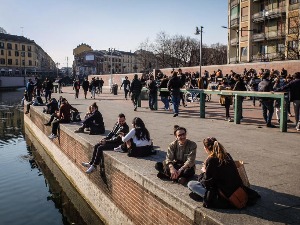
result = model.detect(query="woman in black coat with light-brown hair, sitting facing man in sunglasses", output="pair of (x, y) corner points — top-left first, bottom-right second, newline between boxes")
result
(188, 137), (260, 208)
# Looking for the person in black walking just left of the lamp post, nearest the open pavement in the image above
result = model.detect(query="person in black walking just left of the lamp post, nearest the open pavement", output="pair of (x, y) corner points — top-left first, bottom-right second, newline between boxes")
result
(167, 71), (182, 117)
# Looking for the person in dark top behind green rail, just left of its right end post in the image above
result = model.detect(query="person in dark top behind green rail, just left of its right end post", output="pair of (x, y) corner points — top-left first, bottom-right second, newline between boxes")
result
(258, 72), (276, 128)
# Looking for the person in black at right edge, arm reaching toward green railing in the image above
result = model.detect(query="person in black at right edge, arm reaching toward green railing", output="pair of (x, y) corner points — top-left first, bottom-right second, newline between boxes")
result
(278, 72), (300, 131)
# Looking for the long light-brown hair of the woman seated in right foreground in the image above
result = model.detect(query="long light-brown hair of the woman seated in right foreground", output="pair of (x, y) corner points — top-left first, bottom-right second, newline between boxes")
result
(203, 137), (228, 164)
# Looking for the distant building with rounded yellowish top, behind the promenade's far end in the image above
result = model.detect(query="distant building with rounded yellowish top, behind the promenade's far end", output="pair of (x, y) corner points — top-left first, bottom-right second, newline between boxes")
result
(73, 44), (140, 77)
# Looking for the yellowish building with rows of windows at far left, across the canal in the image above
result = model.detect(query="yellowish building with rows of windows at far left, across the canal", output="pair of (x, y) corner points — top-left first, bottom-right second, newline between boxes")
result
(0, 33), (56, 76)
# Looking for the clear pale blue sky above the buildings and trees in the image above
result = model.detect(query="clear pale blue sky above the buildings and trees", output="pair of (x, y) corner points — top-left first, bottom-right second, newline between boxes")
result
(0, 0), (228, 68)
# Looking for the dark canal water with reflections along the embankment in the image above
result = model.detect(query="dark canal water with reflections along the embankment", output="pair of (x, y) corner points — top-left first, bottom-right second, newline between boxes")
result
(0, 90), (103, 225)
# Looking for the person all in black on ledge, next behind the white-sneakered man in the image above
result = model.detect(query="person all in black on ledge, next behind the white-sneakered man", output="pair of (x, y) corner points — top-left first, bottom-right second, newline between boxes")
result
(75, 102), (105, 134)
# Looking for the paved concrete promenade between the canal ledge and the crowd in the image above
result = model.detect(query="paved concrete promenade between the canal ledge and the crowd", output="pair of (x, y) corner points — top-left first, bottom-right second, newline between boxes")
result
(53, 87), (300, 224)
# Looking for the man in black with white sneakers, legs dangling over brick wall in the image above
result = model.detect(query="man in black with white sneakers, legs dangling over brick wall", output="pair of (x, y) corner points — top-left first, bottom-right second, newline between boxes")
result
(82, 113), (129, 173)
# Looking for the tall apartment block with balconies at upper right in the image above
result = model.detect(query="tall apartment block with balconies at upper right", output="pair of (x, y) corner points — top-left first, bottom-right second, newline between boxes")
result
(224, 0), (300, 63)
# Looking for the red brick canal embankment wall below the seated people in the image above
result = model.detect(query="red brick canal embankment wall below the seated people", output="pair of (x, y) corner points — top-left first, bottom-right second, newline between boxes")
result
(25, 107), (195, 225)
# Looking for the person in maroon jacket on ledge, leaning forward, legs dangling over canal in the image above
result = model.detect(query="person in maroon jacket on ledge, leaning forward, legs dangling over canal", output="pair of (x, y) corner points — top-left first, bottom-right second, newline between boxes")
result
(49, 98), (78, 139)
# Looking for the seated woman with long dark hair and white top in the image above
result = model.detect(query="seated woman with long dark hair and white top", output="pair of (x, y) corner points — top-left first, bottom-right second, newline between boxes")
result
(114, 117), (153, 157)
